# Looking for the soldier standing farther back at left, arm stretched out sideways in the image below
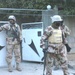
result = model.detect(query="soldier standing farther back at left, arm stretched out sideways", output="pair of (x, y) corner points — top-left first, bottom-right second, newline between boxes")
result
(0, 15), (21, 72)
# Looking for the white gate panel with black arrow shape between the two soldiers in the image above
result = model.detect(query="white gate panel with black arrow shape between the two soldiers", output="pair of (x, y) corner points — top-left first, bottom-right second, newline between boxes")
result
(22, 22), (43, 62)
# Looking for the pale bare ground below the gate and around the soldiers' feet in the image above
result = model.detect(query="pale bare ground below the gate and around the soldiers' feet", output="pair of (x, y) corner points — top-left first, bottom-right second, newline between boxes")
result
(0, 62), (75, 75)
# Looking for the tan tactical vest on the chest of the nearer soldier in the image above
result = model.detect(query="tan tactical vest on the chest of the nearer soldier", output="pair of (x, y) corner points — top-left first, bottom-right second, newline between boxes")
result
(48, 29), (62, 43)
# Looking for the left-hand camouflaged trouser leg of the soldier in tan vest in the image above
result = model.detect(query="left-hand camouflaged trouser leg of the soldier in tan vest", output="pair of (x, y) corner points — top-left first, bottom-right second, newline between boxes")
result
(46, 53), (53, 75)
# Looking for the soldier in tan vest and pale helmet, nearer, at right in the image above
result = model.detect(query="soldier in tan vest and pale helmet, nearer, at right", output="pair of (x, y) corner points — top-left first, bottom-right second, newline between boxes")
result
(40, 15), (68, 75)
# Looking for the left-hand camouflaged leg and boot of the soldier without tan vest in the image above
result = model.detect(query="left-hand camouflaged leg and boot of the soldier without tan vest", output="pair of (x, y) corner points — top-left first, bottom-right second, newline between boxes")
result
(6, 44), (13, 72)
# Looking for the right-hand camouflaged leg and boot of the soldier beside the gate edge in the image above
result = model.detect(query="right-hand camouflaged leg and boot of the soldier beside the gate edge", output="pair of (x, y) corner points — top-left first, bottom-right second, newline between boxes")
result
(14, 45), (21, 71)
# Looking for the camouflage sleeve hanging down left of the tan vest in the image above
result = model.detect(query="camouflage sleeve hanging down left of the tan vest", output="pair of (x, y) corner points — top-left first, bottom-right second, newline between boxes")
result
(40, 27), (52, 49)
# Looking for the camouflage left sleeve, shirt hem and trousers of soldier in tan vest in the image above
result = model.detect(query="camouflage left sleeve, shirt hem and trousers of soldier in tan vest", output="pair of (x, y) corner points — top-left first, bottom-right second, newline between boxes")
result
(40, 26), (68, 75)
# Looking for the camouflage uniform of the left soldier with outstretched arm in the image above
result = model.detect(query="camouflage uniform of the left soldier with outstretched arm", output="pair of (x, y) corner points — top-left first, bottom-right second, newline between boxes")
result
(0, 23), (21, 69)
